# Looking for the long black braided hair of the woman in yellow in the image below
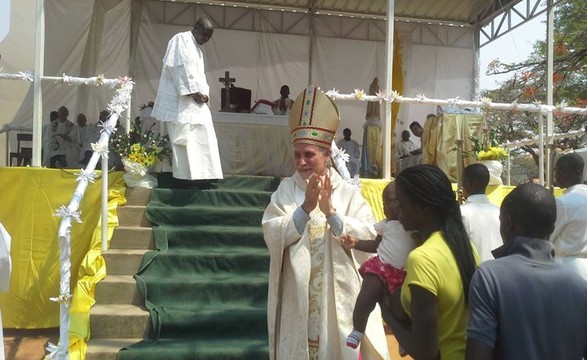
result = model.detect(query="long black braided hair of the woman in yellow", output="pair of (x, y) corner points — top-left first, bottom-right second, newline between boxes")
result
(395, 165), (475, 302)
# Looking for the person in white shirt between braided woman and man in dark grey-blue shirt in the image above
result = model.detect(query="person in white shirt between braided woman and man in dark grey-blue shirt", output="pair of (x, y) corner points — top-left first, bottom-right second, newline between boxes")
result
(461, 164), (503, 262)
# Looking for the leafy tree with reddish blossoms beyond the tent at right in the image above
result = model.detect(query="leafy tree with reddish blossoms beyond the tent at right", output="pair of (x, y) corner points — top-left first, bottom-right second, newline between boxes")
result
(481, 0), (587, 173)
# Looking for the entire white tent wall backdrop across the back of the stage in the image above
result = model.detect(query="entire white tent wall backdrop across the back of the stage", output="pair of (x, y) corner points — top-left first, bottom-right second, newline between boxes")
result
(0, 0), (475, 166)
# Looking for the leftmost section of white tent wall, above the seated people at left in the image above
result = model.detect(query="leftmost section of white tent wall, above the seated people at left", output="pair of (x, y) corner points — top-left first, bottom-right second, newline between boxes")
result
(11, 0), (131, 136)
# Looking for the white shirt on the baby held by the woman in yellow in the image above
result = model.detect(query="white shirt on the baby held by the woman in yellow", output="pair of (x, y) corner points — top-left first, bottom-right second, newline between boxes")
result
(375, 220), (417, 269)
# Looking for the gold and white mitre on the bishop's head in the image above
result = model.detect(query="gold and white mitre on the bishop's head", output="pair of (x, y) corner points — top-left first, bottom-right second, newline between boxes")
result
(289, 85), (340, 149)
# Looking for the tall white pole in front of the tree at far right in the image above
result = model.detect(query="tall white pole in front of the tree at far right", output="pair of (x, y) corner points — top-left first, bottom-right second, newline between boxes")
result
(546, 0), (554, 186)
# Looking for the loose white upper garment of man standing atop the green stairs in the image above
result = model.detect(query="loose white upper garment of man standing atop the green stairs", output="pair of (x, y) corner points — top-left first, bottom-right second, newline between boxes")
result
(151, 31), (212, 125)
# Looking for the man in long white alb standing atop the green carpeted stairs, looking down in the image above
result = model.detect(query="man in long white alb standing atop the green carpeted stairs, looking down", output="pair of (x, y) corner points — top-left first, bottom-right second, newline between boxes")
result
(151, 18), (223, 181)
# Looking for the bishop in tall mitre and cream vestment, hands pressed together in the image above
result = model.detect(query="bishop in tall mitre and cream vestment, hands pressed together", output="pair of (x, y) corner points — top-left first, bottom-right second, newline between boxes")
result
(262, 86), (389, 360)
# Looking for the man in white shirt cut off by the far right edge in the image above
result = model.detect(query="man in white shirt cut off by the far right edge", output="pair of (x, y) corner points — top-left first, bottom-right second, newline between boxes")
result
(550, 153), (587, 280)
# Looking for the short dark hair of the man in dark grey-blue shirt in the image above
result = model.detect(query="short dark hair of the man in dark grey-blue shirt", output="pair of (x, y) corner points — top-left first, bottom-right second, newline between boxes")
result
(501, 183), (556, 239)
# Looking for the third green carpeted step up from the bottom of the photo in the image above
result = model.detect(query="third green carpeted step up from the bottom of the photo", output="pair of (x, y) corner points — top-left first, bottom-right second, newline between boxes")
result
(142, 272), (269, 306)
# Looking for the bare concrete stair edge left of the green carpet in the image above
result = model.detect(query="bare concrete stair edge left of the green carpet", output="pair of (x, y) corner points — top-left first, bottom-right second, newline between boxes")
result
(86, 188), (155, 360)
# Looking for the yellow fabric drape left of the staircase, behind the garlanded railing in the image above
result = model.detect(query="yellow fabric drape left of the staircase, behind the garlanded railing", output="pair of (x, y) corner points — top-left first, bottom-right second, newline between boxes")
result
(0, 167), (124, 329)
